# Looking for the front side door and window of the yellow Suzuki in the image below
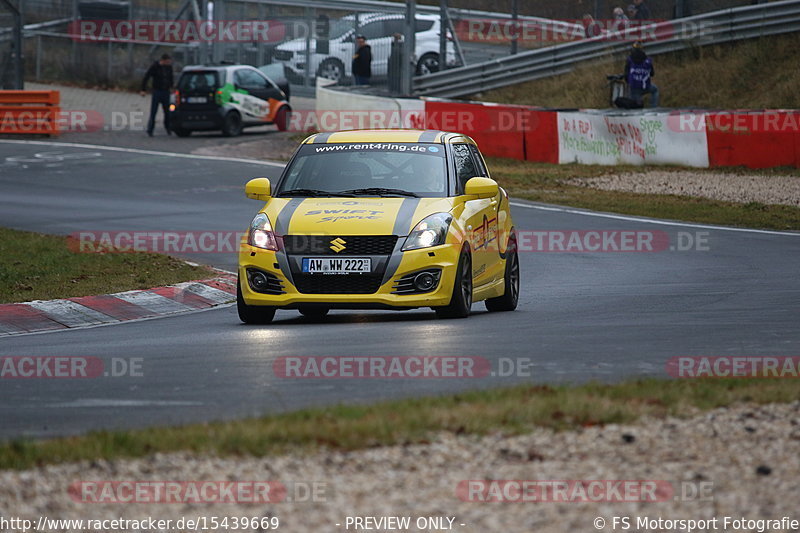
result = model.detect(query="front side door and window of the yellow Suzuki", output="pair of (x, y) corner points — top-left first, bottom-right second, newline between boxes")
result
(452, 143), (498, 286)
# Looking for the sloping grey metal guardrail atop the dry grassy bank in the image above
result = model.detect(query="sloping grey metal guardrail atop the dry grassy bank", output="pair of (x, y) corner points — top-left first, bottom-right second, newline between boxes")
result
(414, 0), (800, 98)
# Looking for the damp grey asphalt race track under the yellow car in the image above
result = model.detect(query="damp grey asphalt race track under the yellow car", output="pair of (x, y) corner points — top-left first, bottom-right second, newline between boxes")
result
(0, 141), (800, 438)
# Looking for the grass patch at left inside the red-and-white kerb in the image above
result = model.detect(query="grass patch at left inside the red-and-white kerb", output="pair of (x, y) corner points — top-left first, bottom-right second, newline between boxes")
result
(0, 228), (214, 303)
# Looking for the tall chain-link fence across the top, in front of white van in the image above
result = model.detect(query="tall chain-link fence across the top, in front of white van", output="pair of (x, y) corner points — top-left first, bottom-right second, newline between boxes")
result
(15, 0), (772, 92)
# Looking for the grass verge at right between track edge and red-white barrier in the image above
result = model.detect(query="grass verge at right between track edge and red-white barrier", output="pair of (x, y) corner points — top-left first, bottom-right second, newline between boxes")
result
(489, 158), (800, 230)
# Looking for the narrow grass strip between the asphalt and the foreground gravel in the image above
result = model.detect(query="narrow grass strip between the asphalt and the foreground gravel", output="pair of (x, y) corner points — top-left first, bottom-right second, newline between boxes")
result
(0, 379), (800, 469)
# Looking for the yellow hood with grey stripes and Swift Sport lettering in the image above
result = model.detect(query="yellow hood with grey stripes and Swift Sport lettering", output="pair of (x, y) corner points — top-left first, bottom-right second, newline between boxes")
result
(261, 197), (454, 235)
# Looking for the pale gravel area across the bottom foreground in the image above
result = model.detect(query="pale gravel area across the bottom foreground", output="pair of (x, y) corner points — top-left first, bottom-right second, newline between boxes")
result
(0, 402), (800, 533)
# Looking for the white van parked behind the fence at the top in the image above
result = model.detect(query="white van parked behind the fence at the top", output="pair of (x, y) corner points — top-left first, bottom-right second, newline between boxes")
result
(273, 13), (455, 83)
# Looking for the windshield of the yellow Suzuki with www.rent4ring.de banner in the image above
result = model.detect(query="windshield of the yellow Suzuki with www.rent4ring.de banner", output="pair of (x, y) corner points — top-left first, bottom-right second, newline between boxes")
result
(276, 143), (447, 197)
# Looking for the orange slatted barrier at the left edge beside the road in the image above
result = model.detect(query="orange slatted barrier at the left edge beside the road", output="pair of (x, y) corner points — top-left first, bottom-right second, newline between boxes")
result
(0, 91), (61, 135)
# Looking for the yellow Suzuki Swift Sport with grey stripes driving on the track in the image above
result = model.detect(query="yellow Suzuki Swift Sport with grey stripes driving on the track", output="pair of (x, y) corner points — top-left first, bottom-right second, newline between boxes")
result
(237, 130), (520, 324)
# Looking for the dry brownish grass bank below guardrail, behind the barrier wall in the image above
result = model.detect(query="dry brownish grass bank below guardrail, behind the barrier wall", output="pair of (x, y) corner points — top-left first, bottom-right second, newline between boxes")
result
(471, 33), (800, 109)
